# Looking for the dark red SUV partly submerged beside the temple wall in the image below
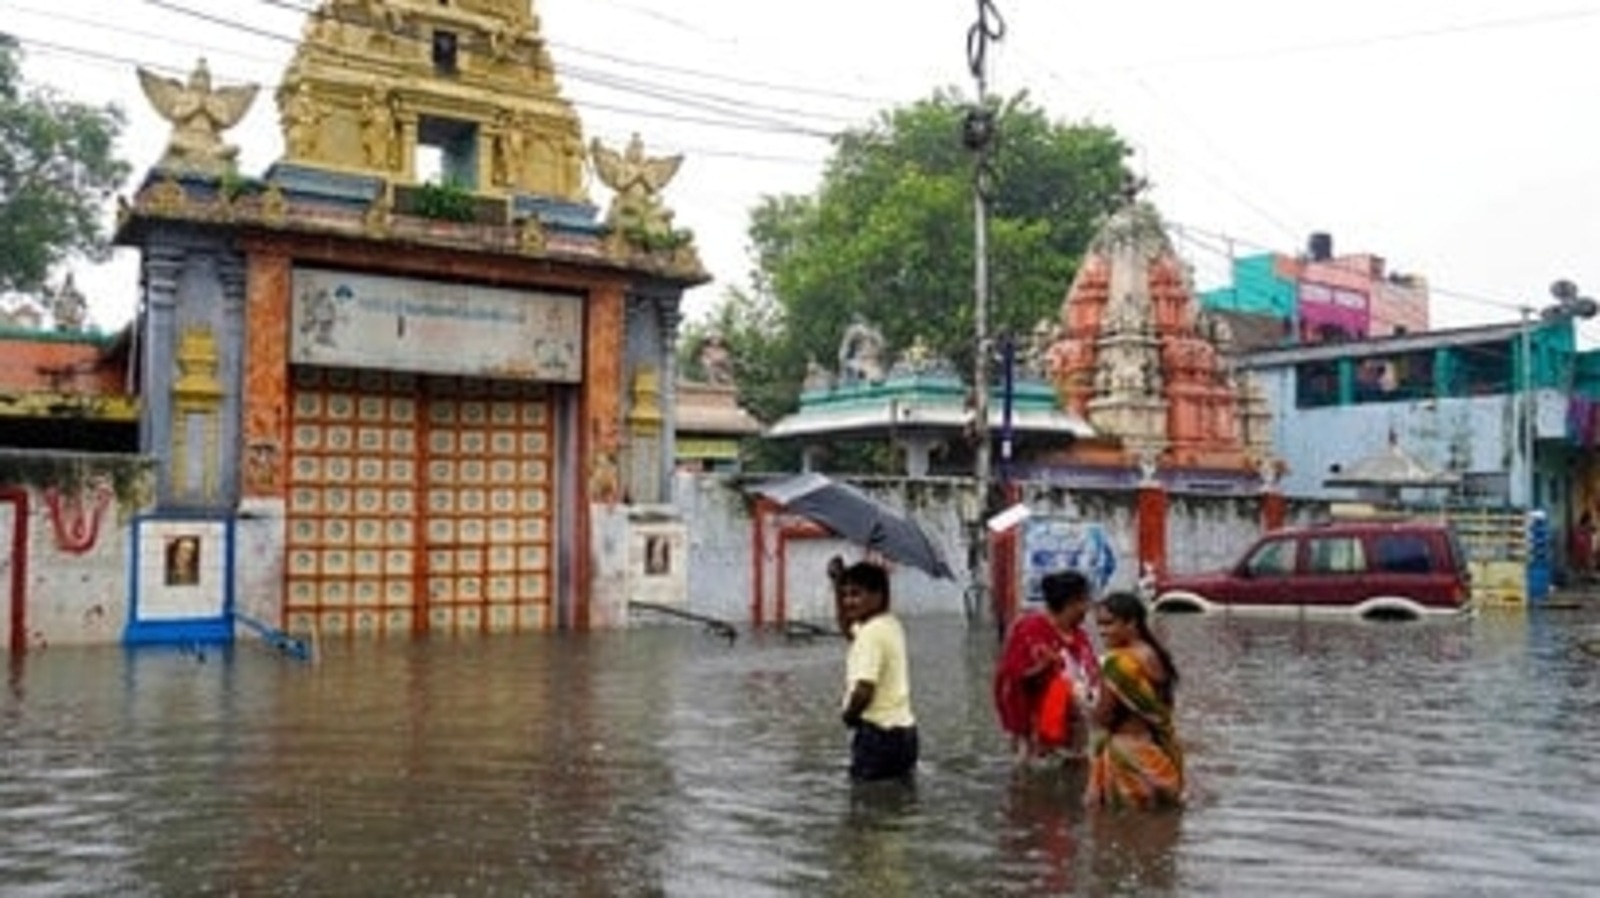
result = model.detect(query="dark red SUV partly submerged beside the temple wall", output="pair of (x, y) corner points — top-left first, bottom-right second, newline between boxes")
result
(1152, 520), (1472, 619)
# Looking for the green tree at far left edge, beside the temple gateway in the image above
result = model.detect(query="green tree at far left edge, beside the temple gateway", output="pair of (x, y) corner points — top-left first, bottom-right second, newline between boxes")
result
(0, 34), (128, 293)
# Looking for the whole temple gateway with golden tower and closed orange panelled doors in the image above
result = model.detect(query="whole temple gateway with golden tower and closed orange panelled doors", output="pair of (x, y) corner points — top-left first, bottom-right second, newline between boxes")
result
(117, 0), (709, 642)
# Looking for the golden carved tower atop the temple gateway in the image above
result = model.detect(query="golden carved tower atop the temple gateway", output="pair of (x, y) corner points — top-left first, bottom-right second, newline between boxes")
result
(277, 0), (587, 202)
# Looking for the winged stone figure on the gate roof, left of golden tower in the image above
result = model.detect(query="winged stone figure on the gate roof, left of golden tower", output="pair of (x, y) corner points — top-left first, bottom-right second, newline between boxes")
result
(139, 58), (259, 176)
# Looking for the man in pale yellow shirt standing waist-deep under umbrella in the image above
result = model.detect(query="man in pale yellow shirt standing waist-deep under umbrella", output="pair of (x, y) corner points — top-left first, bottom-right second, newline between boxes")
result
(838, 562), (918, 783)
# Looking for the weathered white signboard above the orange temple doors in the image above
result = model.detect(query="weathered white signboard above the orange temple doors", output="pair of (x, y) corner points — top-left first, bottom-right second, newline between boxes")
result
(290, 269), (584, 383)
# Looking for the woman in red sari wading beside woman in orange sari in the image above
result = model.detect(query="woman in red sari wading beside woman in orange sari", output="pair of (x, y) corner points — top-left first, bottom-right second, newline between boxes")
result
(994, 570), (1099, 760)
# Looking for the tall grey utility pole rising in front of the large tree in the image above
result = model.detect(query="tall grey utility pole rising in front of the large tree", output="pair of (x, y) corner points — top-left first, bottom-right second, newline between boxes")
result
(962, 0), (1005, 619)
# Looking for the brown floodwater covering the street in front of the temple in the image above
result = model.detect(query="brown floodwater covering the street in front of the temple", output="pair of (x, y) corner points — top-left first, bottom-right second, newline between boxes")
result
(0, 610), (1600, 898)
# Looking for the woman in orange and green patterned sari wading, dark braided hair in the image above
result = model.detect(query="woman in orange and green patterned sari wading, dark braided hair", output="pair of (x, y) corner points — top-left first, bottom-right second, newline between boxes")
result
(1088, 592), (1184, 808)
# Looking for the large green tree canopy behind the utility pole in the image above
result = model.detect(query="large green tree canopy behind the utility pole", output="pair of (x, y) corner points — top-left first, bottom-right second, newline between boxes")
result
(700, 91), (1128, 444)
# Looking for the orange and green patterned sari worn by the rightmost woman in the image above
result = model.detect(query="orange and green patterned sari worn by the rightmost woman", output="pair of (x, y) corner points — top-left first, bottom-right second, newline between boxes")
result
(1088, 648), (1184, 808)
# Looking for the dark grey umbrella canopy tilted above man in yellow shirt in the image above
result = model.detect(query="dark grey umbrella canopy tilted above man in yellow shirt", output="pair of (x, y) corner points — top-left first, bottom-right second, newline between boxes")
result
(754, 474), (955, 579)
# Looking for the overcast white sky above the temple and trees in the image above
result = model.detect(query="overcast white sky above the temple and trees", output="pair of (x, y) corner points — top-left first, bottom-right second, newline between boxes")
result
(0, 0), (1600, 343)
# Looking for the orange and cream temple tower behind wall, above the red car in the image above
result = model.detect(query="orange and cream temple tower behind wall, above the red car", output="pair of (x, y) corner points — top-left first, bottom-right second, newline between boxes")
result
(1048, 194), (1277, 491)
